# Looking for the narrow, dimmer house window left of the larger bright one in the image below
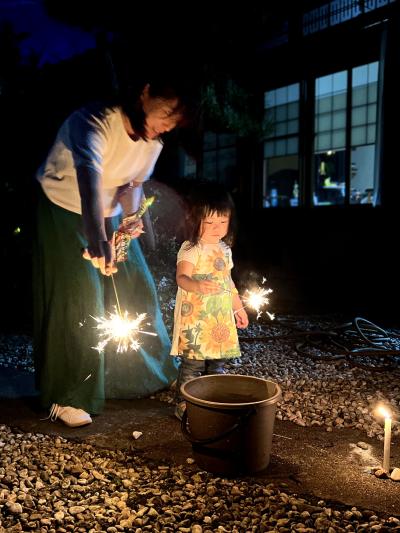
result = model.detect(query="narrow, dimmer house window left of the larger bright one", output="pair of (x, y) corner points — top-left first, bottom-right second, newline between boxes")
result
(263, 83), (300, 207)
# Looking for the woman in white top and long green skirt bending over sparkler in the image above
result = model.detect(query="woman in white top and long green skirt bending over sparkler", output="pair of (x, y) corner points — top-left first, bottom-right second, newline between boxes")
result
(34, 75), (196, 427)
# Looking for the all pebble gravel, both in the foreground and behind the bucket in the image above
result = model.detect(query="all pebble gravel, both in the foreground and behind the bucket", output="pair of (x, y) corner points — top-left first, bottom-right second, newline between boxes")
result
(0, 252), (400, 533)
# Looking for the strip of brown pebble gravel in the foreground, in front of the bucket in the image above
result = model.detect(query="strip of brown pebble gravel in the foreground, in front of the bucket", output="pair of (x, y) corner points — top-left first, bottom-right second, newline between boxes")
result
(0, 420), (400, 533)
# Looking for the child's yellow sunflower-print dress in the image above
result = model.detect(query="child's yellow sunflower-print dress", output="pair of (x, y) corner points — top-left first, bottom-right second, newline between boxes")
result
(171, 241), (240, 360)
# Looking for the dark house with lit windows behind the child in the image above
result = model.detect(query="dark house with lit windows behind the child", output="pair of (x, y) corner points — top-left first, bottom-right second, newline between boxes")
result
(178, 0), (400, 318)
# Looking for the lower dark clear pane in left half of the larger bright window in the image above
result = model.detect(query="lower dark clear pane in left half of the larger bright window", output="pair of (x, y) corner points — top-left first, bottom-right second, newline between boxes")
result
(313, 150), (345, 205)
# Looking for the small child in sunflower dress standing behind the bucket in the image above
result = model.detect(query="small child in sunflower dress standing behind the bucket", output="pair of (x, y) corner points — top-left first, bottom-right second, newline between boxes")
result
(171, 183), (249, 419)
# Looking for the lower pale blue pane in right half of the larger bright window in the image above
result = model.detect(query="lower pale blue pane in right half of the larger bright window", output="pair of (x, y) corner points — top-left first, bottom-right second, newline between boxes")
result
(350, 146), (375, 204)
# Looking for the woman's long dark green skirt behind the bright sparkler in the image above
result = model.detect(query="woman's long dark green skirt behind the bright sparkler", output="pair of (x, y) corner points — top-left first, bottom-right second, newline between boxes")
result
(33, 192), (177, 414)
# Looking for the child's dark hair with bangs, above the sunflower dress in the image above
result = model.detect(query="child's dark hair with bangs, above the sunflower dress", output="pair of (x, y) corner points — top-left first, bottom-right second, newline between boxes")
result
(186, 182), (236, 246)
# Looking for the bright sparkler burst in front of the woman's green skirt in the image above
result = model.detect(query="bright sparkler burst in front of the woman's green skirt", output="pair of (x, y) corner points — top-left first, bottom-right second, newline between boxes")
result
(92, 309), (157, 353)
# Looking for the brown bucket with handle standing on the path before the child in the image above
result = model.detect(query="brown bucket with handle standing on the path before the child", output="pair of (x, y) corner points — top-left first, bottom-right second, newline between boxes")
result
(181, 374), (282, 475)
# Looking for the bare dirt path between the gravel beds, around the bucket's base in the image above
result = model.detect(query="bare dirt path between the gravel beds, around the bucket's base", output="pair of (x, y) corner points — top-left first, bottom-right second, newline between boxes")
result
(0, 373), (400, 517)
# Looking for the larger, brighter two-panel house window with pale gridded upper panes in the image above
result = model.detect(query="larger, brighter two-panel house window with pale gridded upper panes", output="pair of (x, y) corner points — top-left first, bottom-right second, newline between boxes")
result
(313, 62), (378, 205)
